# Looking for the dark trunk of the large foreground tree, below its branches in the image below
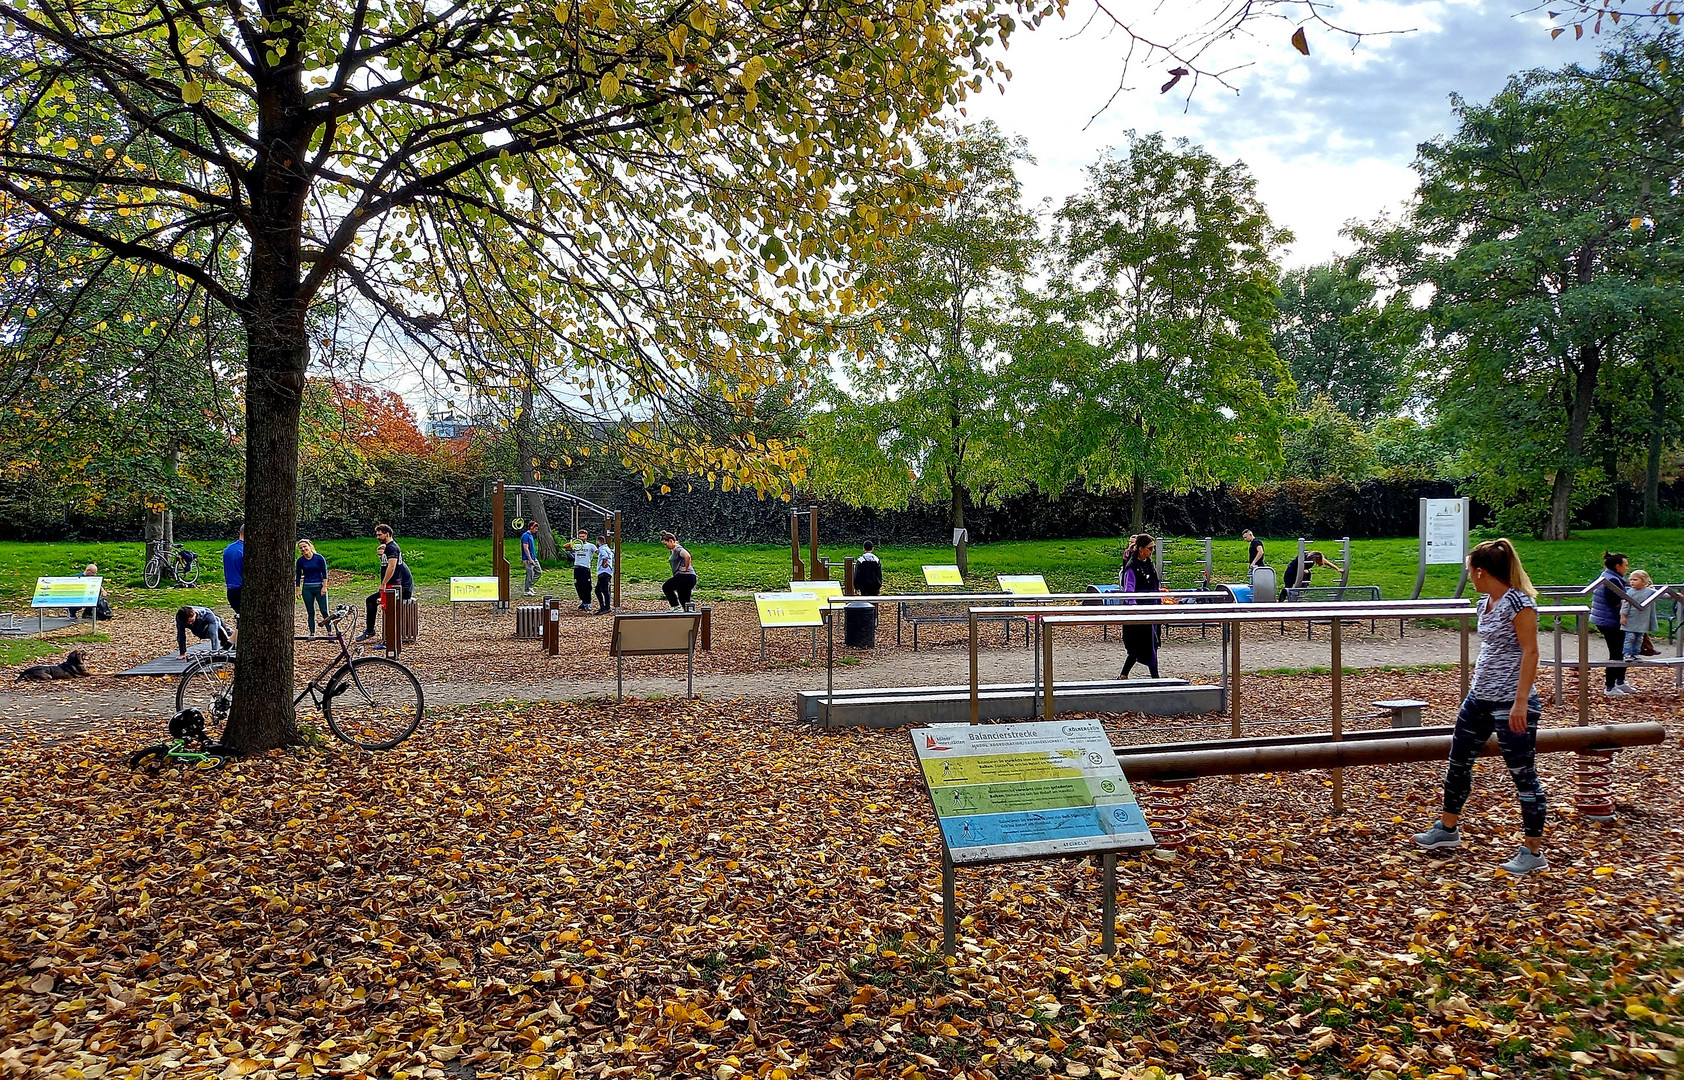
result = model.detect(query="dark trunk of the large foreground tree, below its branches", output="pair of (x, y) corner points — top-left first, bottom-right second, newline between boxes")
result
(222, 305), (310, 753)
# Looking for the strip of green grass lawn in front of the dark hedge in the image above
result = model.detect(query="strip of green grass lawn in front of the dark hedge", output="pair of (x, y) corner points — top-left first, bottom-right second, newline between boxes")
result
(0, 529), (1684, 610)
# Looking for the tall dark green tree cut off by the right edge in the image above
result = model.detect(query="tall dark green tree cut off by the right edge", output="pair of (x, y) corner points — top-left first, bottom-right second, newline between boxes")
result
(1371, 30), (1684, 539)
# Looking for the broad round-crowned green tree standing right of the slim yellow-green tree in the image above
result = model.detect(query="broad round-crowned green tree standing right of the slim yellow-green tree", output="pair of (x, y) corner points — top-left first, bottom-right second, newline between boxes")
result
(1017, 133), (1295, 531)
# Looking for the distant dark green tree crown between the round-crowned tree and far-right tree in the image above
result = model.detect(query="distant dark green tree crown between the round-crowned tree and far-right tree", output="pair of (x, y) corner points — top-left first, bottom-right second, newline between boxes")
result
(1270, 259), (1408, 423)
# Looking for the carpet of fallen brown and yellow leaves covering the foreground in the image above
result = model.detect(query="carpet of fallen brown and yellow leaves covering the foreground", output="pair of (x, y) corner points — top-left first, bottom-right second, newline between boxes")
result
(0, 674), (1684, 1080)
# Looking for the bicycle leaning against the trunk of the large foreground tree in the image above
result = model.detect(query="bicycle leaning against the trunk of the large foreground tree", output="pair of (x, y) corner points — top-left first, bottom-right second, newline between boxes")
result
(175, 607), (423, 750)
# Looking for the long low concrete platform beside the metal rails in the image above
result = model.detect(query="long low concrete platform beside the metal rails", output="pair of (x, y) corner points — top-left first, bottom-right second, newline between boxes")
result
(795, 679), (1223, 728)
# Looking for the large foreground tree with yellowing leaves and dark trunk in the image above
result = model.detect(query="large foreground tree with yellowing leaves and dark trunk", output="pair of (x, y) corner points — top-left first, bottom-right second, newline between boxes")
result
(0, 0), (1044, 751)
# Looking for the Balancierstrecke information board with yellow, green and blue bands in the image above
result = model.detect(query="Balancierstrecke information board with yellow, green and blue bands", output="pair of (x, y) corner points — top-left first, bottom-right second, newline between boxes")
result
(911, 719), (1155, 866)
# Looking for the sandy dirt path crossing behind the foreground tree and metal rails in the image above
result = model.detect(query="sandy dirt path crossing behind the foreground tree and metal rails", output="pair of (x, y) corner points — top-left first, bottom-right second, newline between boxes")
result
(0, 627), (1460, 735)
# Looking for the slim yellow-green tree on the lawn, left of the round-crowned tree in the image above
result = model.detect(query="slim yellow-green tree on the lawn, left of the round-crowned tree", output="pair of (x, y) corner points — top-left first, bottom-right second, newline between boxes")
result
(810, 123), (1037, 573)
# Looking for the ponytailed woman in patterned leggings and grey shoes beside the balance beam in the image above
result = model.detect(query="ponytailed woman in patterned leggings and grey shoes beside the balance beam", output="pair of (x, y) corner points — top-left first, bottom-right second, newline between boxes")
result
(1415, 539), (1549, 876)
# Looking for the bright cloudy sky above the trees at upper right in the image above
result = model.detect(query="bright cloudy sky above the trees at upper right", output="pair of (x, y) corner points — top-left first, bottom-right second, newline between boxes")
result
(967, 0), (1600, 265)
